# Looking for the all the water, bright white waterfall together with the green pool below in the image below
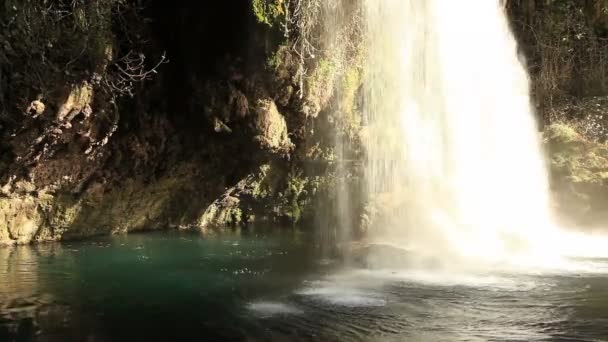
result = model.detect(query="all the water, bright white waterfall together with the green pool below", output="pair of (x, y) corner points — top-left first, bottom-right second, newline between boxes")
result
(0, 0), (608, 342)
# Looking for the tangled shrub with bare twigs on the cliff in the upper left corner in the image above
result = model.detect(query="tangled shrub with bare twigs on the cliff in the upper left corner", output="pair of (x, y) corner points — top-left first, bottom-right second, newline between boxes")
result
(0, 0), (165, 116)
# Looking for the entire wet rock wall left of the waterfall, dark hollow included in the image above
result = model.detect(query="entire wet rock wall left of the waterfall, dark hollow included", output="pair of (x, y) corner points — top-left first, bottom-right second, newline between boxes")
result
(0, 0), (364, 243)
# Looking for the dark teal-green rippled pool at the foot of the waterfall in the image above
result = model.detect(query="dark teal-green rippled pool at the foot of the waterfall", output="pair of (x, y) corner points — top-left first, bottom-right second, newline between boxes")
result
(0, 231), (608, 342)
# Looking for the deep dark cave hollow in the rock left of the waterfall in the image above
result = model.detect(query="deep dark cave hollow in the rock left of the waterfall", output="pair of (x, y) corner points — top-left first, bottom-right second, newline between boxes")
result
(114, 0), (270, 187)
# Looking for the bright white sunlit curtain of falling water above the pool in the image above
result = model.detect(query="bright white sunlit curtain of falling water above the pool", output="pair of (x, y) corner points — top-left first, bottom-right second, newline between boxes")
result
(363, 0), (604, 268)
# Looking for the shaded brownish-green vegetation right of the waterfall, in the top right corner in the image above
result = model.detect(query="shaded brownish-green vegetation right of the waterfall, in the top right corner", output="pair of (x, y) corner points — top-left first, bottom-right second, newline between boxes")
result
(507, 0), (608, 109)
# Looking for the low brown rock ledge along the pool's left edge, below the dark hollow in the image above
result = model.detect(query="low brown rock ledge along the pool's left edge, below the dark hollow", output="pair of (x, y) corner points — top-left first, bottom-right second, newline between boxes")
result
(0, 164), (226, 245)
